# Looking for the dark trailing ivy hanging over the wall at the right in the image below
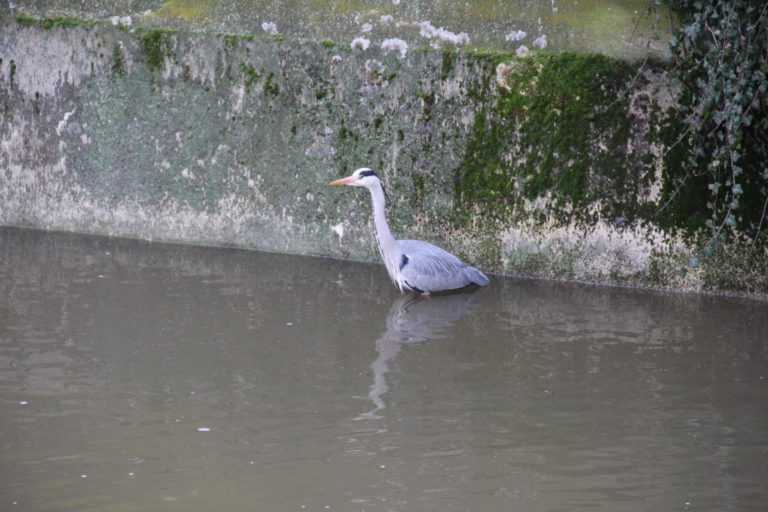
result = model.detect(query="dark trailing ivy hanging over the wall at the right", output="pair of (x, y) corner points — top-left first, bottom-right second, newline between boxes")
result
(668, 0), (768, 249)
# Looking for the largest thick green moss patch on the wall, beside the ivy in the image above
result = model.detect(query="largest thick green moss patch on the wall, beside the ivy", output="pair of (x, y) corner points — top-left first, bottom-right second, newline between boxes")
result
(456, 53), (650, 223)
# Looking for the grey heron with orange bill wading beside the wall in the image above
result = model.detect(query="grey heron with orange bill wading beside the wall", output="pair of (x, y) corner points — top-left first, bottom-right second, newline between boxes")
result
(331, 167), (490, 295)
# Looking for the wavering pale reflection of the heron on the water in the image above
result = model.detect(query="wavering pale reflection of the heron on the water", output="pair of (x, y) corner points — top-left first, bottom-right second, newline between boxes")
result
(355, 288), (485, 420)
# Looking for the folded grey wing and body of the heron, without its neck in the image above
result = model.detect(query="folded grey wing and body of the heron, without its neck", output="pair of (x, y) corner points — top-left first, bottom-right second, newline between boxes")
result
(398, 240), (488, 293)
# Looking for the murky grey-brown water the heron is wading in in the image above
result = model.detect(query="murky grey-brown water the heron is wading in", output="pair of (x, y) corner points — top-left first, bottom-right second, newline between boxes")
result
(0, 229), (768, 511)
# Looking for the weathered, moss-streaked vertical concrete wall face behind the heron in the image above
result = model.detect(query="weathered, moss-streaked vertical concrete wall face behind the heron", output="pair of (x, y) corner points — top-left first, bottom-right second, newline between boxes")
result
(0, 17), (768, 295)
